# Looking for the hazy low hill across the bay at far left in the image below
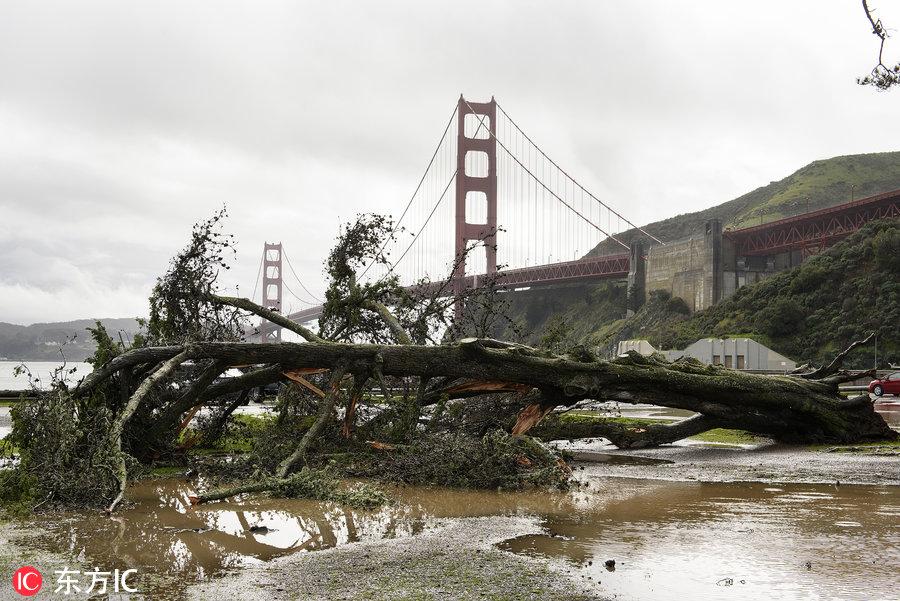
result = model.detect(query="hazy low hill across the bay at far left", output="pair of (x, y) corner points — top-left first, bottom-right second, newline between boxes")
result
(0, 318), (139, 361)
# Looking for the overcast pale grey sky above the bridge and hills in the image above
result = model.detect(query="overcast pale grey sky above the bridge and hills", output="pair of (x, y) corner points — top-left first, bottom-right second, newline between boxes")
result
(0, 0), (900, 324)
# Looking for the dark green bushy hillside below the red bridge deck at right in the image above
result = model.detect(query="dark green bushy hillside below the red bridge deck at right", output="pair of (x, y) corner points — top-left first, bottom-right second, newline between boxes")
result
(591, 219), (900, 367)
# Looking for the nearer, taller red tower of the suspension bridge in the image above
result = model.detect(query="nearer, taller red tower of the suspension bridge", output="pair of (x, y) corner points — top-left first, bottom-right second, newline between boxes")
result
(453, 94), (497, 318)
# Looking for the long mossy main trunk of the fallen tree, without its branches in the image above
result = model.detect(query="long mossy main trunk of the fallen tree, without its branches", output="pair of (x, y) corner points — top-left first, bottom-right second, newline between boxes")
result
(81, 339), (897, 446)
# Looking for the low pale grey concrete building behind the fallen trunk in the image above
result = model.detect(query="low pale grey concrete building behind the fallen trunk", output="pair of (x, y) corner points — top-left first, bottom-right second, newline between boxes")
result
(617, 338), (797, 372)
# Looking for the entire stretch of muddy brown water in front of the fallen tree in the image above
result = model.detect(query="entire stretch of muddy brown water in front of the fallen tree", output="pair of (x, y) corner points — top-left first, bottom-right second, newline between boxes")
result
(37, 479), (900, 601)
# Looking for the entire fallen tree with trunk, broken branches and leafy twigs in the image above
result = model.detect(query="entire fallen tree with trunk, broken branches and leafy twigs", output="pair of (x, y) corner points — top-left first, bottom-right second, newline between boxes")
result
(5, 209), (897, 511)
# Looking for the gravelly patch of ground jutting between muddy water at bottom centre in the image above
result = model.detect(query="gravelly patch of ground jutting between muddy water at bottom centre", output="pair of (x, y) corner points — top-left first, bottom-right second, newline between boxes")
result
(188, 517), (601, 601)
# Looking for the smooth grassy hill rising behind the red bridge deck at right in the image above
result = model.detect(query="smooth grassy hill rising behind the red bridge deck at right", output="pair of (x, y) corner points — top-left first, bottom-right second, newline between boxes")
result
(588, 152), (900, 255)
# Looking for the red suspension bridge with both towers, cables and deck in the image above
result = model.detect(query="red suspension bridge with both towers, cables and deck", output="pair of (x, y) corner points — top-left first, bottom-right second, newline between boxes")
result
(253, 96), (900, 341)
